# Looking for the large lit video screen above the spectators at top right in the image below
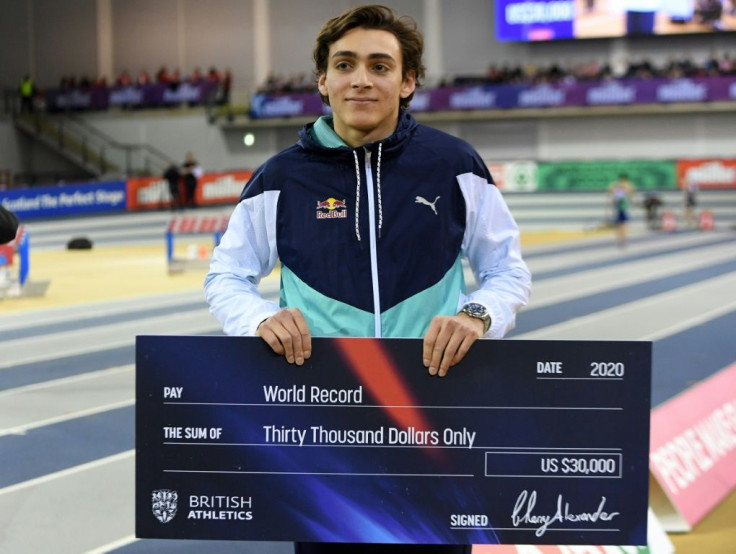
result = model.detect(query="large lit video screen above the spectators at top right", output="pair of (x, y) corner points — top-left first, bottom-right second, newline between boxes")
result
(494, 0), (736, 41)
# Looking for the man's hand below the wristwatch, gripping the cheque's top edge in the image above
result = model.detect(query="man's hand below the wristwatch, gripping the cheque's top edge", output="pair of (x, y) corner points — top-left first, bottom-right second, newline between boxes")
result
(422, 313), (483, 377)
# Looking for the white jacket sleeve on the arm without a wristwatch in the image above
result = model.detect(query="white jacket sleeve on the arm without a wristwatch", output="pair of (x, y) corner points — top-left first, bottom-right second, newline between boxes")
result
(204, 191), (279, 336)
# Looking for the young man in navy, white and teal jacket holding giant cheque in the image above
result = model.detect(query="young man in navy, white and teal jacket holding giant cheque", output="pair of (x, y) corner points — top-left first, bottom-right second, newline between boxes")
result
(205, 6), (530, 553)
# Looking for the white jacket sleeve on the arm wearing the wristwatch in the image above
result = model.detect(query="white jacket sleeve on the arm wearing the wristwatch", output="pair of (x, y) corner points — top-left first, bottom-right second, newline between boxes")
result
(458, 173), (531, 338)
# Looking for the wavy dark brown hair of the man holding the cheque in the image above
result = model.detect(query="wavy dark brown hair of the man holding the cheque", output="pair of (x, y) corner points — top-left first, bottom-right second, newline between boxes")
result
(313, 5), (424, 108)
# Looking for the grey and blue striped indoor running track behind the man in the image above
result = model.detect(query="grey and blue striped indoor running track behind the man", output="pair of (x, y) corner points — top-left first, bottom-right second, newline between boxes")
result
(0, 191), (736, 554)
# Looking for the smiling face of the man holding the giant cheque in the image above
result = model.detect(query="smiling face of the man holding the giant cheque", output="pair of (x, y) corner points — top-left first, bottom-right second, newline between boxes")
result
(319, 28), (416, 146)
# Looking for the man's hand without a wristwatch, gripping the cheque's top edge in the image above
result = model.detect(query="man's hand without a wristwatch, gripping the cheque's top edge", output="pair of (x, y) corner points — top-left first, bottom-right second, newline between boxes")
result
(256, 308), (312, 365)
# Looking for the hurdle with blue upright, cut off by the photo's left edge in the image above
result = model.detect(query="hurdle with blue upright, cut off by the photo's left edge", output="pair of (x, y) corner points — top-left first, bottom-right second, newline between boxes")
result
(0, 225), (51, 298)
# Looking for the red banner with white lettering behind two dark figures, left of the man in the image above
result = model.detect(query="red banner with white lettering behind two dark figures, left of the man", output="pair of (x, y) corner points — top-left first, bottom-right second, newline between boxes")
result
(126, 170), (253, 210)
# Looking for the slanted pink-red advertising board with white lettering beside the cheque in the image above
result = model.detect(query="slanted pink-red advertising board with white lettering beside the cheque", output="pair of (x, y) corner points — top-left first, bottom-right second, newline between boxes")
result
(649, 363), (736, 531)
